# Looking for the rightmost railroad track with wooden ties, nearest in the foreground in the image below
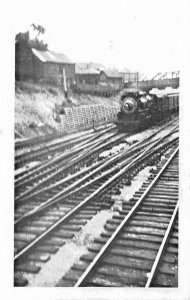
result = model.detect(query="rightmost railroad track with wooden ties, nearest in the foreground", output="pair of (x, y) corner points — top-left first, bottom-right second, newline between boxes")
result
(61, 148), (179, 287)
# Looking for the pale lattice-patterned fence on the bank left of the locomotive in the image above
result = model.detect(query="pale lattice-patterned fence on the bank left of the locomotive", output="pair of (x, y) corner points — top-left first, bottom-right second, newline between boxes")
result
(61, 104), (119, 129)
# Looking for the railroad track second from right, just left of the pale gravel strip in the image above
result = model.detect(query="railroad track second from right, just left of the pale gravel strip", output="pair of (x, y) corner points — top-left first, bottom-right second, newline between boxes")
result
(15, 132), (176, 285)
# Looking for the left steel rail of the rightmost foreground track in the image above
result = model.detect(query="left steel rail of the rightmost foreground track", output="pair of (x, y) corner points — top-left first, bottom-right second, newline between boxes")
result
(74, 147), (179, 287)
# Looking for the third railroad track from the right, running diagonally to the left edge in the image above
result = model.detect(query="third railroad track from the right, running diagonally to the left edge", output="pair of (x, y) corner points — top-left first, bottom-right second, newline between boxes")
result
(15, 123), (177, 219)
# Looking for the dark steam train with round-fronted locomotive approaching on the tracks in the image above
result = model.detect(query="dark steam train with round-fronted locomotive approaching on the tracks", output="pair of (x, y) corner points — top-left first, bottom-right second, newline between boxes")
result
(116, 89), (179, 131)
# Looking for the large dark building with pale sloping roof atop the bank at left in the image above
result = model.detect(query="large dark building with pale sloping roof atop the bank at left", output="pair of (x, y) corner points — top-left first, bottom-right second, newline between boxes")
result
(15, 43), (75, 84)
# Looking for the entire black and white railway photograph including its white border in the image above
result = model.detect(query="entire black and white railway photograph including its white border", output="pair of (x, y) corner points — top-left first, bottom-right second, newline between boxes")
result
(0, 0), (190, 300)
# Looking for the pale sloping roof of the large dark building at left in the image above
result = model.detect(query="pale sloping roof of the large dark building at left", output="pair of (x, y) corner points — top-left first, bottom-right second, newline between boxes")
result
(32, 48), (73, 64)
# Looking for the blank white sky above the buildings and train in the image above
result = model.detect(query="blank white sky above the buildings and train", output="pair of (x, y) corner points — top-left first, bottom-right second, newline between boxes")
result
(6, 0), (189, 75)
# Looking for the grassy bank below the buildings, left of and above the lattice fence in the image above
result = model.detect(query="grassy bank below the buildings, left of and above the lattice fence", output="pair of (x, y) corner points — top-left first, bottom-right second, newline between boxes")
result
(15, 82), (118, 137)
